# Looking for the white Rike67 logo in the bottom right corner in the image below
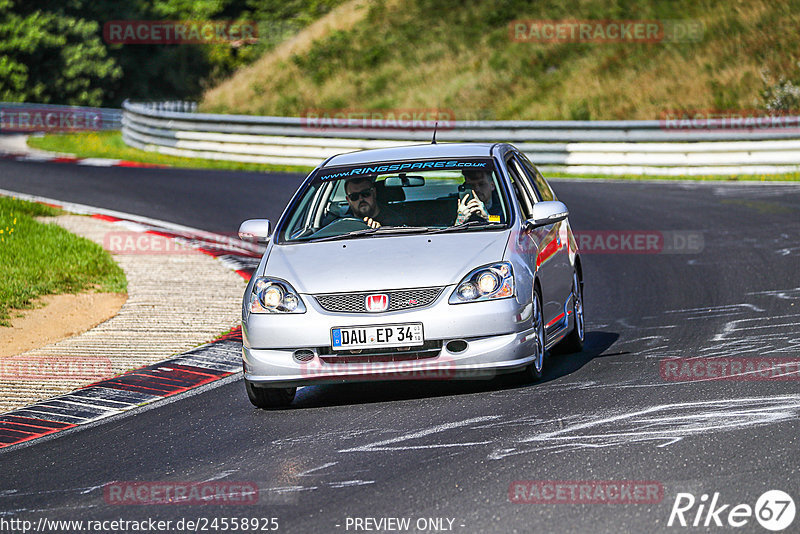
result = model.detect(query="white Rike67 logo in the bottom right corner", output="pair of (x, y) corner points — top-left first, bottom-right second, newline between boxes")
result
(667, 490), (796, 532)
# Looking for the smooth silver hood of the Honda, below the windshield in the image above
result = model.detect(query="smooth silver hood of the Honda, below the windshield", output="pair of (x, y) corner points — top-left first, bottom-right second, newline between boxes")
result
(265, 230), (509, 294)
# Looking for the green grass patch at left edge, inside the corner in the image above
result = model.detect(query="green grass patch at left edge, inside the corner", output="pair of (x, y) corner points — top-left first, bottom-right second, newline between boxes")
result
(0, 197), (127, 326)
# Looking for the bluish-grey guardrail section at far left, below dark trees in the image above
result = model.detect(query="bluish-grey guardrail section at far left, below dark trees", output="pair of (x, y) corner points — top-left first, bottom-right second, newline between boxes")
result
(0, 102), (122, 133)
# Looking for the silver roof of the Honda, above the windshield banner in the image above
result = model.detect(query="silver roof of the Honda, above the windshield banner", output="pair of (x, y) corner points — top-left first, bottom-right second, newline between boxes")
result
(323, 143), (495, 167)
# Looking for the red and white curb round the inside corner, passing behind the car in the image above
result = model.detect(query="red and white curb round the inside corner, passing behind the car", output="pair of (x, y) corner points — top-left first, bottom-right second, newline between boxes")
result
(0, 189), (264, 449)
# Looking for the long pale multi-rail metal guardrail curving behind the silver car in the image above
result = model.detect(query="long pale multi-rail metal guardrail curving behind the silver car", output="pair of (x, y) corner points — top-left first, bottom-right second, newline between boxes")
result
(122, 102), (800, 175)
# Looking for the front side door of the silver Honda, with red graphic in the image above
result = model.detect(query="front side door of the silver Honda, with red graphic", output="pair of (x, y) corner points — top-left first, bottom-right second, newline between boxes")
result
(506, 154), (564, 331)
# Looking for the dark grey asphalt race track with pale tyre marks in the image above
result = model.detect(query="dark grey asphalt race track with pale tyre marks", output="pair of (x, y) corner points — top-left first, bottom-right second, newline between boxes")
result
(0, 161), (800, 532)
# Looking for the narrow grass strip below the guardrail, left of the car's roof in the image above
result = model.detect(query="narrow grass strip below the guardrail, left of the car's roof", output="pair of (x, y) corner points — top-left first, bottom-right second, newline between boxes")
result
(28, 131), (312, 174)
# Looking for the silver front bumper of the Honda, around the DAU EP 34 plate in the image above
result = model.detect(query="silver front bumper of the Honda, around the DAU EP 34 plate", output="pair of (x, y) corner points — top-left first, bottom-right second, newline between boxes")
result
(242, 286), (536, 387)
